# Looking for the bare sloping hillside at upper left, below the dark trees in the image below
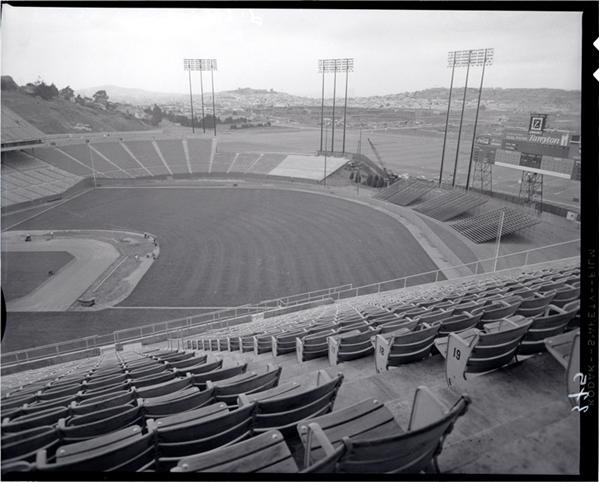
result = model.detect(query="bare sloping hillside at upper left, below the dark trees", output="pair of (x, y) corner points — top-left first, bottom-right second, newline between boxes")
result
(2, 90), (151, 134)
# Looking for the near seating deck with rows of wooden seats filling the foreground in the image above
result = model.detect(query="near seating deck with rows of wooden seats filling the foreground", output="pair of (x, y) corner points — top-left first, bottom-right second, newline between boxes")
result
(1, 260), (580, 473)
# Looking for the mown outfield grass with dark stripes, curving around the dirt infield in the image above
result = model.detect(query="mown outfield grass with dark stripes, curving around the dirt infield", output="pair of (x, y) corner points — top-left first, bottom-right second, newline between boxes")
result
(3, 188), (436, 350)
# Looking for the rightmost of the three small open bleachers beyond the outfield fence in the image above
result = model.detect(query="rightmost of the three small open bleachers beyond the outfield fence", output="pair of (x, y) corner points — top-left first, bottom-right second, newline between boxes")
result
(451, 208), (540, 243)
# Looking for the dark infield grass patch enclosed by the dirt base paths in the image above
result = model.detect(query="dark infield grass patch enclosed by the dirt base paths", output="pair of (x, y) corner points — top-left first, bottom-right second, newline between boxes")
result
(2, 251), (73, 301)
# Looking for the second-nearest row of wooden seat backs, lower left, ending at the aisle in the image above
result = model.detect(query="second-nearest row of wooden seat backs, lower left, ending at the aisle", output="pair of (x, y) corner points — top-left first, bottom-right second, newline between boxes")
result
(2, 372), (343, 470)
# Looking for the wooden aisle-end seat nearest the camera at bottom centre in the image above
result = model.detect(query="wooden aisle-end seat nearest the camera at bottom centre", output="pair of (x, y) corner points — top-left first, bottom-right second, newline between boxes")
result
(298, 386), (470, 474)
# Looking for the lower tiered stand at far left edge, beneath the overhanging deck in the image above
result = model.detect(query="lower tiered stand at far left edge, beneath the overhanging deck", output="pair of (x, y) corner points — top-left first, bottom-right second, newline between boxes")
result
(2, 151), (82, 207)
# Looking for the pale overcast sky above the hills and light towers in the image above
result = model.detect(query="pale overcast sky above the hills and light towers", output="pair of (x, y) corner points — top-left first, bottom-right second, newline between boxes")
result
(1, 5), (581, 97)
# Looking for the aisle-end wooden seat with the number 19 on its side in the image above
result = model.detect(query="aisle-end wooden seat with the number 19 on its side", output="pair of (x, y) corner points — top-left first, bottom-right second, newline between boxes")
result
(434, 315), (533, 389)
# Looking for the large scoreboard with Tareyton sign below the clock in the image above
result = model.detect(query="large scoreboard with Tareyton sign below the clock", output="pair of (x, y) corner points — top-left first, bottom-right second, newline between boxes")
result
(473, 129), (581, 181)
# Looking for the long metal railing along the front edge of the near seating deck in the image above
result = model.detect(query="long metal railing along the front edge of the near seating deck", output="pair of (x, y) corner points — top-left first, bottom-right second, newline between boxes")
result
(0, 239), (581, 364)
